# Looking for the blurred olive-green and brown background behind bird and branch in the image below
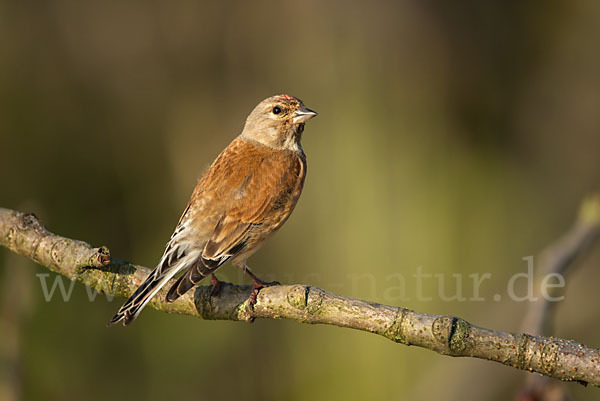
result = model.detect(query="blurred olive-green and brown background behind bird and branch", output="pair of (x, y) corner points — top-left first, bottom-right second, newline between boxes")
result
(0, 0), (600, 401)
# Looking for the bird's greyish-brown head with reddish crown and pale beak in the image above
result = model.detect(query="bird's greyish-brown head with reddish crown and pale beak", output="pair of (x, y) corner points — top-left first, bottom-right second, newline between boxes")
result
(241, 95), (317, 150)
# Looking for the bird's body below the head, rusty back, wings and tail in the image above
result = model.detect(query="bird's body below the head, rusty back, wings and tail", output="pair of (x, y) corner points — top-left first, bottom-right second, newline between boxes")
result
(110, 138), (306, 324)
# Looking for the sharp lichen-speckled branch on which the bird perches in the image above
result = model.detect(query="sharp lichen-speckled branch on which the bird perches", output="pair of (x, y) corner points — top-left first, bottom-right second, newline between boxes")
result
(0, 205), (600, 386)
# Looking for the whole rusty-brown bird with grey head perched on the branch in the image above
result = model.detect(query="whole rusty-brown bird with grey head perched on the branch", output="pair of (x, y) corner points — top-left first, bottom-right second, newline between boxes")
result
(107, 94), (317, 326)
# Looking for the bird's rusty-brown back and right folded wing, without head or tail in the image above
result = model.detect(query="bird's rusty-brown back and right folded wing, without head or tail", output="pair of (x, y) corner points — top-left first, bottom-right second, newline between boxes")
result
(167, 140), (306, 301)
